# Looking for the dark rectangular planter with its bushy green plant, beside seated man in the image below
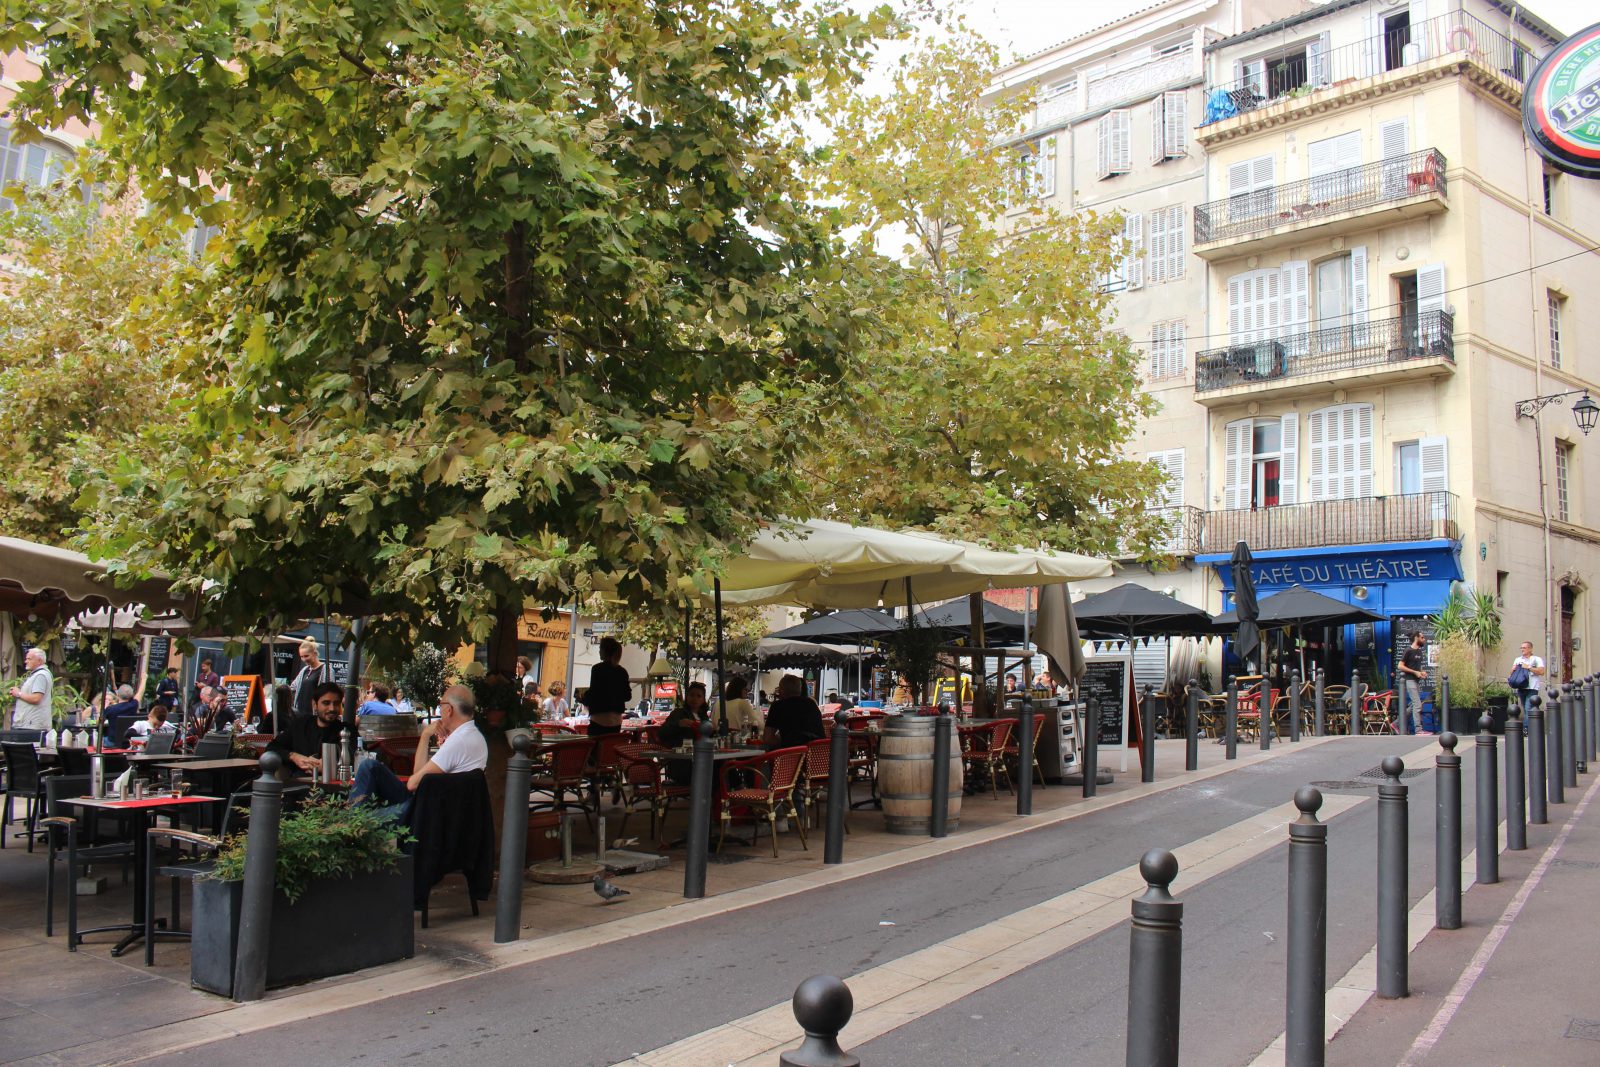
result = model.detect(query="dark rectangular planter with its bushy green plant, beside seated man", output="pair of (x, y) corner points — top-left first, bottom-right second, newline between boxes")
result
(189, 793), (414, 997)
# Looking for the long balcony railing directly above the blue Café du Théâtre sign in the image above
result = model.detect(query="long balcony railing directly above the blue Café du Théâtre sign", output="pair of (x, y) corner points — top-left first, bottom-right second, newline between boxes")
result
(1202, 493), (1461, 552)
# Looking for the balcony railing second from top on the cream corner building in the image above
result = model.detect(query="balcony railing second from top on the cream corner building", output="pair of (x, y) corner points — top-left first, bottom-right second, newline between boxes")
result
(1195, 149), (1448, 245)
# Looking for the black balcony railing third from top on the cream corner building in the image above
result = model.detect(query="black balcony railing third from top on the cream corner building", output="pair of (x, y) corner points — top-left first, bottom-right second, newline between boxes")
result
(1195, 312), (1456, 394)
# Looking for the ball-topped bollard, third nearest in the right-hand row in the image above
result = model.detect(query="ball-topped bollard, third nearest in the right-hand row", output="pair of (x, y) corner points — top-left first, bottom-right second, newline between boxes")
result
(1283, 785), (1328, 1067)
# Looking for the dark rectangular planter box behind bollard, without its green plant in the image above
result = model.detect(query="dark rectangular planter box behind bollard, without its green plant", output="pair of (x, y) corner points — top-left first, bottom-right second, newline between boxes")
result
(189, 856), (416, 997)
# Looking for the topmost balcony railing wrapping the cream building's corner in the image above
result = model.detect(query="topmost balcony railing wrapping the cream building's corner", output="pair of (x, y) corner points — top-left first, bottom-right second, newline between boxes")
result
(1200, 11), (1538, 125)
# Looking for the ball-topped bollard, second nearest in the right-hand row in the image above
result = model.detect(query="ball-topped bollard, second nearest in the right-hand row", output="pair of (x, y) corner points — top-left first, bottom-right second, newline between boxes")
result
(1126, 848), (1184, 1067)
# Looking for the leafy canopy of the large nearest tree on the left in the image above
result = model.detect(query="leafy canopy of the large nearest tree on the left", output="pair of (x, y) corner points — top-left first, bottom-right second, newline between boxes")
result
(0, 0), (893, 662)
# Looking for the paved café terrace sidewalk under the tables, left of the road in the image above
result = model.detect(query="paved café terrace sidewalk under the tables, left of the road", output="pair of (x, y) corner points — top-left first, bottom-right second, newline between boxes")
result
(0, 739), (1337, 1064)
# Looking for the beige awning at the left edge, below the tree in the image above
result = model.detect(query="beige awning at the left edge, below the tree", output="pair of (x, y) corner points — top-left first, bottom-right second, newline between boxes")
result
(0, 537), (189, 616)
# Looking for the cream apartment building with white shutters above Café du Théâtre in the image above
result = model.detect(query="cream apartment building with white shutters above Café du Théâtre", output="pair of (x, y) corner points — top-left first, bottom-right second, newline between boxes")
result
(1006, 0), (1600, 677)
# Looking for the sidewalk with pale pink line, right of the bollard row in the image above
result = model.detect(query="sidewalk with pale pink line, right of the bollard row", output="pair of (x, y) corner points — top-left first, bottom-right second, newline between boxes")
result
(1328, 774), (1600, 1067)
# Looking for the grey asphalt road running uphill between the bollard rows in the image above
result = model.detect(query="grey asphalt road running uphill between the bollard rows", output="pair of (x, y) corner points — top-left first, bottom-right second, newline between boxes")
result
(147, 739), (1452, 1067)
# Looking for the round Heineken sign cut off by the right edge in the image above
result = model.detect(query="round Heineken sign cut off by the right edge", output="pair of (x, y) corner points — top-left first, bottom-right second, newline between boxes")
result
(1522, 24), (1600, 178)
